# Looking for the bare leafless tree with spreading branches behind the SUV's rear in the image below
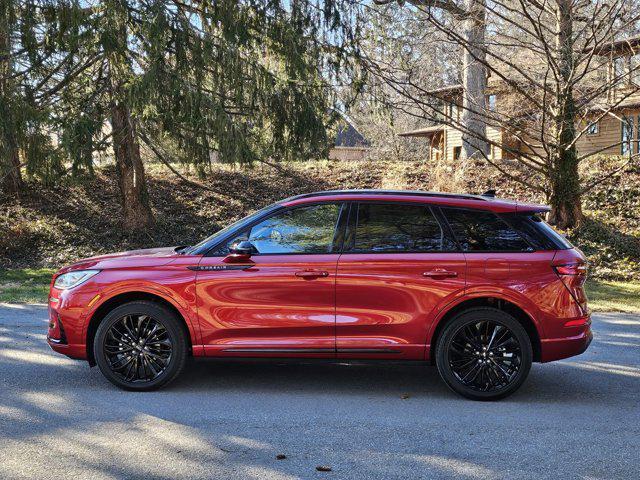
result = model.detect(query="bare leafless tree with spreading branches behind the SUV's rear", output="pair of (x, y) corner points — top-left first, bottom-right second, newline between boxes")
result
(366, 0), (640, 228)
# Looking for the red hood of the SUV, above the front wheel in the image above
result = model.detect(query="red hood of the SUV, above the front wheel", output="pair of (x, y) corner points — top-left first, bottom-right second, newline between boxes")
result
(59, 247), (180, 273)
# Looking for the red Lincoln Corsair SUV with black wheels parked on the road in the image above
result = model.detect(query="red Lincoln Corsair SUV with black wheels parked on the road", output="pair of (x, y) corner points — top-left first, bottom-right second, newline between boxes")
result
(48, 190), (592, 400)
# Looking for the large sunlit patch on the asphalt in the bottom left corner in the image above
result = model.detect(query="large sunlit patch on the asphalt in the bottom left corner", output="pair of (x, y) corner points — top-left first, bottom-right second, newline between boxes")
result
(0, 412), (298, 479)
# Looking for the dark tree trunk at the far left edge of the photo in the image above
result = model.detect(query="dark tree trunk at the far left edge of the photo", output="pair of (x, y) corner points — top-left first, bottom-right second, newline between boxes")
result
(0, 1), (23, 195)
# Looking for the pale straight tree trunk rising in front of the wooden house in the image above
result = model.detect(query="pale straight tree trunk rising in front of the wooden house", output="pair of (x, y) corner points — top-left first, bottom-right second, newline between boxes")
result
(462, 0), (489, 158)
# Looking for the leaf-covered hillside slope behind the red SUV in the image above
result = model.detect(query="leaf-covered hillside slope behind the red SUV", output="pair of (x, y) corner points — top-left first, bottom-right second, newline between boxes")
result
(0, 161), (640, 280)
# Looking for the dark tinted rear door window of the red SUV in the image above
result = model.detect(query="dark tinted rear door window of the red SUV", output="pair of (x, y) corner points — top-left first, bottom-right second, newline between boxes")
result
(353, 203), (455, 252)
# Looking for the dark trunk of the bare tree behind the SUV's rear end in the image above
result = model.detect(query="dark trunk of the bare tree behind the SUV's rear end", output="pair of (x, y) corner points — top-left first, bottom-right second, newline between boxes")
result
(549, 0), (583, 228)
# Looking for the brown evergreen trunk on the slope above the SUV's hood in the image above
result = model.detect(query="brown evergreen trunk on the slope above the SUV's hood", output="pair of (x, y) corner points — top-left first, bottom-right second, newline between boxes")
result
(111, 101), (154, 230)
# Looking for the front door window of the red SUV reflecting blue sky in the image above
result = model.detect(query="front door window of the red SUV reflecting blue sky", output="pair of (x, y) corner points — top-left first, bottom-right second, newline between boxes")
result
(225, 204), (340, 254)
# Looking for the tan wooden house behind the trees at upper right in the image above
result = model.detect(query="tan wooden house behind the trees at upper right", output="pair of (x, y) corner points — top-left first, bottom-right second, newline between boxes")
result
(399, 37), (640, 161)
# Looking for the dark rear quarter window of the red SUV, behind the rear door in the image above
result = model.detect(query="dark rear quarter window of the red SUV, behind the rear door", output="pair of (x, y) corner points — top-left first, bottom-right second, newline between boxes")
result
(442, 208), (531, 252)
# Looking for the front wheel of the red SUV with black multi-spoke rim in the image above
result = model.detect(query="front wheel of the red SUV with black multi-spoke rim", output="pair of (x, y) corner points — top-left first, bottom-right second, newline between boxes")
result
(93, 300), (188, 391)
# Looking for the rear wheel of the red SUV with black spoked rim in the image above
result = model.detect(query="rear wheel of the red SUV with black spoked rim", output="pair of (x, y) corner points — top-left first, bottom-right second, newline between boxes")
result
(436, 307), (533, 400)
